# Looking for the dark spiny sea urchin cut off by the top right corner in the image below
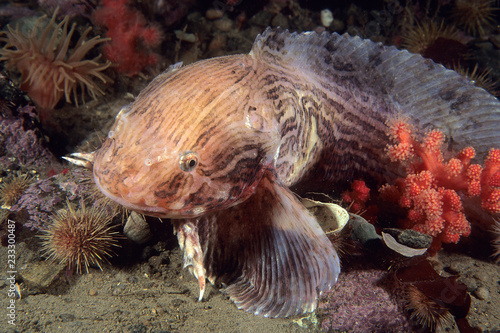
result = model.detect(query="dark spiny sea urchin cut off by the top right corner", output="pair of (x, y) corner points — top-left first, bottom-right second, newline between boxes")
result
(452, 0), (498, 37)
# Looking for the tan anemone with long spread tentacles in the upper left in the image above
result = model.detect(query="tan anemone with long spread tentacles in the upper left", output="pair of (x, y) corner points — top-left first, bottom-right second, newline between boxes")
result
(0, 13), (111, 109)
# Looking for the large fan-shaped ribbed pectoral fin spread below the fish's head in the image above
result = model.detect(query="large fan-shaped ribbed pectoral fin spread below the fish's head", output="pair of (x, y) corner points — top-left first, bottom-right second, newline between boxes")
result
(188, 174), (340, 317)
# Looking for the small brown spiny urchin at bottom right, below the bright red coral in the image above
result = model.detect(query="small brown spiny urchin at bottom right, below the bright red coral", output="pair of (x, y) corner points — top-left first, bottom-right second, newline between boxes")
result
(404, 284), (454, 331)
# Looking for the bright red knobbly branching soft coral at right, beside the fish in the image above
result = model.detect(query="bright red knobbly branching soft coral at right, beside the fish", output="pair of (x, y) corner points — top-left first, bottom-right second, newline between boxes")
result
(380, 121), (500, 249)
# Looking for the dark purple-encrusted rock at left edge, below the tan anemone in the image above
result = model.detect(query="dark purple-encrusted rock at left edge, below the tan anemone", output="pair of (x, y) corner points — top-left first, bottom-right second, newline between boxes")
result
(0, 106), (55, 170)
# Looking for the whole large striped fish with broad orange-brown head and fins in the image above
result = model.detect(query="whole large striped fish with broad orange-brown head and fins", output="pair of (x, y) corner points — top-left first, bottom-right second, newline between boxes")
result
(93, 29), (500, 317)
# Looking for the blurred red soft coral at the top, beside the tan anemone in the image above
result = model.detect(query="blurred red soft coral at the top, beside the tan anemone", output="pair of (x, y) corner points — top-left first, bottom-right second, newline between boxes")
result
(93, 0), (162, 76)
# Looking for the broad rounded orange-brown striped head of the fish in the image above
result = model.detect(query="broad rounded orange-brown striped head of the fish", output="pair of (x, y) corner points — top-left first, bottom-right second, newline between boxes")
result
(93, 58), (279, 218)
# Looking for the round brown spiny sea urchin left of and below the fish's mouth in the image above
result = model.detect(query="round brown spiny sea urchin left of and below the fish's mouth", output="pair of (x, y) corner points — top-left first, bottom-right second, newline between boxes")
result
(40, 203), (118, 273)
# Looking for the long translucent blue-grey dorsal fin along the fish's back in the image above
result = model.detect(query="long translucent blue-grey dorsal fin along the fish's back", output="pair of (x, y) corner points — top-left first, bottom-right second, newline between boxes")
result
(250, 28), (500, 157)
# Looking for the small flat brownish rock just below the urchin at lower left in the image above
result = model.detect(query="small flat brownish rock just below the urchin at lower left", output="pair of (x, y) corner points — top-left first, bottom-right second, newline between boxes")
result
(19, 261), (66, 291)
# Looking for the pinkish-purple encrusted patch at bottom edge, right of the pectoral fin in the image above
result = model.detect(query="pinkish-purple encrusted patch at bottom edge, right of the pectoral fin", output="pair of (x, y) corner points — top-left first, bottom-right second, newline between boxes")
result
(318, 269), (412, 333)
